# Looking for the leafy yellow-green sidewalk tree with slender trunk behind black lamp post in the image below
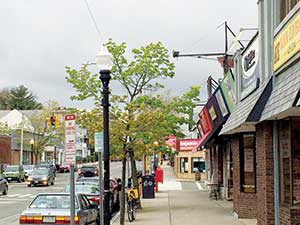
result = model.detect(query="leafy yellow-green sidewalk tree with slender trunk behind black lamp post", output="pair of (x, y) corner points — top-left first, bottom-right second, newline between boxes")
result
(66, 39), (199, 225)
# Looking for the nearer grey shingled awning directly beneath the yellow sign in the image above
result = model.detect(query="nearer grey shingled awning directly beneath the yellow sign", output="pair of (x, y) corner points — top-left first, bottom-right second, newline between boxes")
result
(260, 63), (300, 121)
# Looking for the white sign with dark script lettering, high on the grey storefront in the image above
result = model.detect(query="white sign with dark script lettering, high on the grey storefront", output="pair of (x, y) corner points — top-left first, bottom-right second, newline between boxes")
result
(241, 35), (259, 99)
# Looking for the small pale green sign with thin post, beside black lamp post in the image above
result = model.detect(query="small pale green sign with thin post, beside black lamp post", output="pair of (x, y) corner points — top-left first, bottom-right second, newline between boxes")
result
(94, 132), (104, 225)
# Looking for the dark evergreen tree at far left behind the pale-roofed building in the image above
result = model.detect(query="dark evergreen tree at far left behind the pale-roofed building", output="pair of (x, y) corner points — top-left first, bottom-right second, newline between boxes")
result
(0, 85), (42, 110)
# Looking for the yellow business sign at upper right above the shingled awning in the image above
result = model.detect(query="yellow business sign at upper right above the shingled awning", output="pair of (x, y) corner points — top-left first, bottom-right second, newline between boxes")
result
(273, 10), (300, 71)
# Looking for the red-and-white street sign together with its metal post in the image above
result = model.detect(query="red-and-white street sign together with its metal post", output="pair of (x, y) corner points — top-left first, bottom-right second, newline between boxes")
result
(64, 114), (76, 225)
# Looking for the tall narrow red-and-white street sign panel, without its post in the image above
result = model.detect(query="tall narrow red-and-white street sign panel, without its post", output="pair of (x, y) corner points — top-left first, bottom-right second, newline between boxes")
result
(64, 114), (76, 164)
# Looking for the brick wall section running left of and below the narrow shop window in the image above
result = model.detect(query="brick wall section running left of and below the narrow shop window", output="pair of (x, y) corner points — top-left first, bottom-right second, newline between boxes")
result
(231, 137), (257, 219)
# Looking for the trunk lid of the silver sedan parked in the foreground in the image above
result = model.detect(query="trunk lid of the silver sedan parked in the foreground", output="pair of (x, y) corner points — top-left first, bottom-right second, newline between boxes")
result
(22, 208), (78, 216)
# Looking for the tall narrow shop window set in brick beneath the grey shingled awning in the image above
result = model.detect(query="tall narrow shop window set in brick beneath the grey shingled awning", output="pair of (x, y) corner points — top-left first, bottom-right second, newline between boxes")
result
(240, 134), (256, 193)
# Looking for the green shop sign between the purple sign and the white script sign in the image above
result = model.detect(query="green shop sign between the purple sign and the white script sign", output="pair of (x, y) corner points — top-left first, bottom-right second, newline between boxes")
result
(221, 70), (236, 112)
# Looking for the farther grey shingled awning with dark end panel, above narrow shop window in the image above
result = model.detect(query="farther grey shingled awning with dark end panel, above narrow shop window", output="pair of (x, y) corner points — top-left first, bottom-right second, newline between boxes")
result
(220, 78), (272, 135)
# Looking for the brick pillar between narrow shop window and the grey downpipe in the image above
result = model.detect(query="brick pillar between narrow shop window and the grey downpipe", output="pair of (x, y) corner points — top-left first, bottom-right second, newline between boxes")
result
(256, 121), (274, 225)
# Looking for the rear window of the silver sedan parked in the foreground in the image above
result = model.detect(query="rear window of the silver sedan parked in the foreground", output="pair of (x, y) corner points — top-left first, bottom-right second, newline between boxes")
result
(29, 194), (78, 209)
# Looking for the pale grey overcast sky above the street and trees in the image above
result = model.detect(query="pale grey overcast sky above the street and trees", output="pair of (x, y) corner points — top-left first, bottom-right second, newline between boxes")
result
(0, 0), (257, 108)
